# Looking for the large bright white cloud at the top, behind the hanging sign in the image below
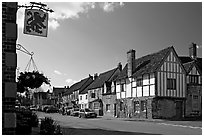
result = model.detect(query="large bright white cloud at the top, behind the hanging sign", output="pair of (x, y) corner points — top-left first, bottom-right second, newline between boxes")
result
(17, 2), (124, 30)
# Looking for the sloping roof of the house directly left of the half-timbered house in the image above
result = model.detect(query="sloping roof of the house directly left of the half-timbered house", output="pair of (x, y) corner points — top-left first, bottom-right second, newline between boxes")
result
(88, 67), (119, 90)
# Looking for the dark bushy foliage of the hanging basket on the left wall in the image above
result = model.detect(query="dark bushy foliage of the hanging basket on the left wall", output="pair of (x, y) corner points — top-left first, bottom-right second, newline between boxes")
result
(17, 71), (50, 93)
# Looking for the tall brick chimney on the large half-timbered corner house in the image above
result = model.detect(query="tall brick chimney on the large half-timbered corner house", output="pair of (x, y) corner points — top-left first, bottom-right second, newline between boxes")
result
(127, 49), (135, 77)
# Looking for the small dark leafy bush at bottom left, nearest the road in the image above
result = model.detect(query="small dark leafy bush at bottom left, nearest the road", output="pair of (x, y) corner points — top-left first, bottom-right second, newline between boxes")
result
(40, 117), (62, 135)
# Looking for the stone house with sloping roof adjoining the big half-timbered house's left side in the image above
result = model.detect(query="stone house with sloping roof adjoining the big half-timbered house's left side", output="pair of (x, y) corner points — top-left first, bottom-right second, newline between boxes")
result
(87, 64), (122, 116)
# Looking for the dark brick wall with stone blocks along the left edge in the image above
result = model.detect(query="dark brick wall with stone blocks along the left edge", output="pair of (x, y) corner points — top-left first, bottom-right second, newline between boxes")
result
(2, 2), (17, 135)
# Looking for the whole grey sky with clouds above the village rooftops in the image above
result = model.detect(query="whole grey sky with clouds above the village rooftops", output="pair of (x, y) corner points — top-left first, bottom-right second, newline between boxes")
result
(17, 2), (202, 91)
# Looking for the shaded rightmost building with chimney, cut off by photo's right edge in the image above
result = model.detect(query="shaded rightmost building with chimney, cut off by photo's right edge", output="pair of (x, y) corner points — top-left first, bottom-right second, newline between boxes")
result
(179, 43), (202, 117)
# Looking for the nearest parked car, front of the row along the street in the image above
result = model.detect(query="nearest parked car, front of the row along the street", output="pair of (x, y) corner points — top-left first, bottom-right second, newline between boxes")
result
(79, 108), (97, 118)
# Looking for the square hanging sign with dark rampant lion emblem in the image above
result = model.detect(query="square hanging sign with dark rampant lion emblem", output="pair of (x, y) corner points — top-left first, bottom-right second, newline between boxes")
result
(23, 9), (48, 37)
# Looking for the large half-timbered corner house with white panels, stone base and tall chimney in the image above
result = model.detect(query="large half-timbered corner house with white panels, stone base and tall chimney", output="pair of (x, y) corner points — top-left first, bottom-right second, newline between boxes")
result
(116, 46), (186, 118)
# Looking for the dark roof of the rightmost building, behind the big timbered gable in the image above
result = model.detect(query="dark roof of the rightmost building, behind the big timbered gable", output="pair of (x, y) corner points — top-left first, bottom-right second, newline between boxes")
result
(179, 56), (202, 73)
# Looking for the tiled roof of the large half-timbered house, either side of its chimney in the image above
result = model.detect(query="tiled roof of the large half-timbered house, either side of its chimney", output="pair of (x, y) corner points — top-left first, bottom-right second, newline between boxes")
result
(117, 46), (174, 79)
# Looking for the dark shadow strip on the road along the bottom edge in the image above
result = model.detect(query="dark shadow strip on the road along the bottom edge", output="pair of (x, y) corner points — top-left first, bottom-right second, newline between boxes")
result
(62, 128), (158, 135)
